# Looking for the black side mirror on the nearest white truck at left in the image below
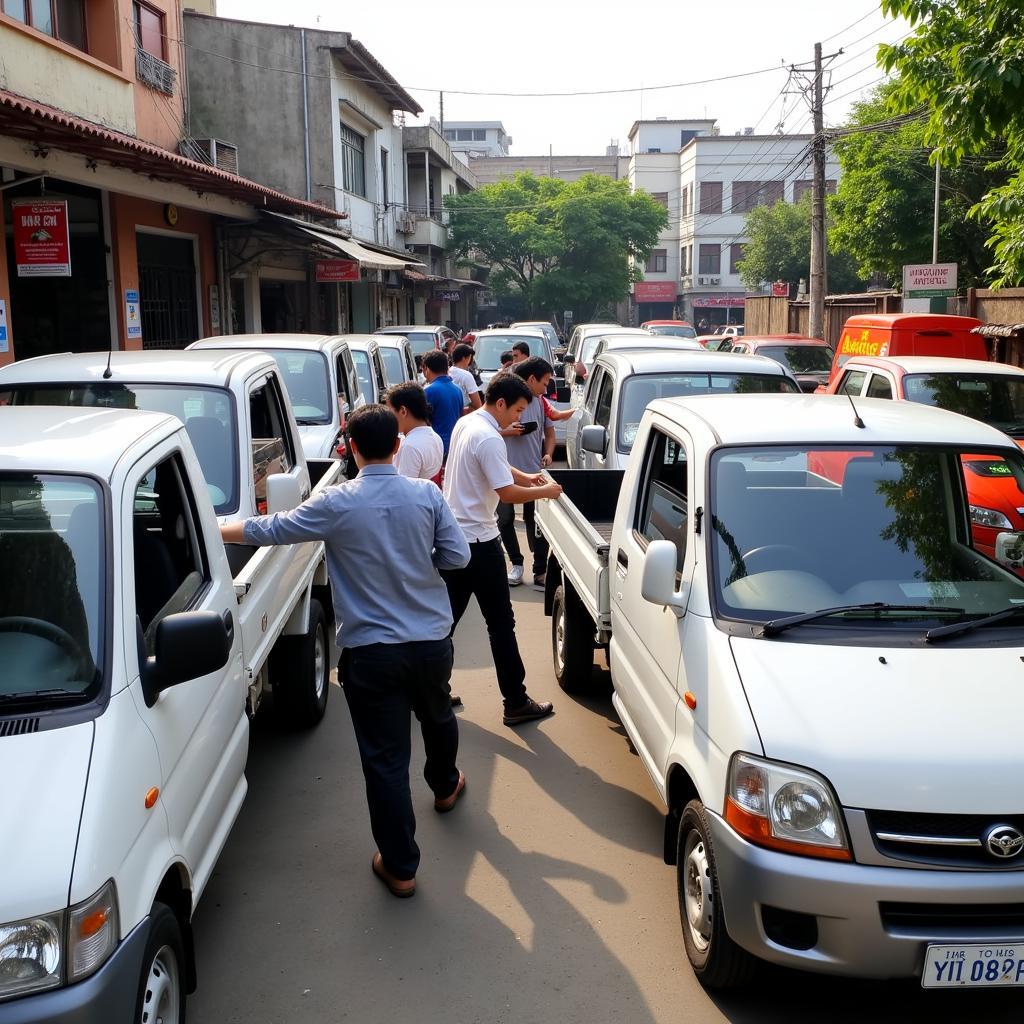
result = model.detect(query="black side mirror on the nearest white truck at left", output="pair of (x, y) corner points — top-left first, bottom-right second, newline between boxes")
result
(140, 611), (234, 708)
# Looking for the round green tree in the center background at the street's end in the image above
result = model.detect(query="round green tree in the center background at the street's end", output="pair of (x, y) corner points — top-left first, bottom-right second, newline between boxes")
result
(444, 172), (669, 321)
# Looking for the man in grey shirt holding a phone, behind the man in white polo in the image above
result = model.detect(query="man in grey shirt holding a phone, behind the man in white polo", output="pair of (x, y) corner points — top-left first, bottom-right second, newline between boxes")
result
(498, 356), (555, 590)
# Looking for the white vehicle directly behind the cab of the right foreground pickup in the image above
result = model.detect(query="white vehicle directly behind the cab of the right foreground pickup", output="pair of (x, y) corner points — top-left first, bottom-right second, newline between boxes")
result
(565, 348), (800, 469)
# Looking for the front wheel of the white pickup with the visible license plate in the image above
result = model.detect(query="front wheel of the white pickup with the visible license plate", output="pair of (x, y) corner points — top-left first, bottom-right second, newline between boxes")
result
(676, 800), (757, 989)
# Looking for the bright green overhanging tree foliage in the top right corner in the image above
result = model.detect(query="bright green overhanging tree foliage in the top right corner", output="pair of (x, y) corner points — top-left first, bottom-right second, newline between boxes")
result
(879, 0), (1024, 285)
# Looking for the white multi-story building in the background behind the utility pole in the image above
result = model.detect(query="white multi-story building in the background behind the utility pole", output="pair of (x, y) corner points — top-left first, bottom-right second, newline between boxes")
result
(630, 120), (840, 326)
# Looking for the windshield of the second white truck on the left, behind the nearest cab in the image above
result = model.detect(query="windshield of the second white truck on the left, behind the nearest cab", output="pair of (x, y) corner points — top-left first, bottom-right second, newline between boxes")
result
(0, 381), (239, 515)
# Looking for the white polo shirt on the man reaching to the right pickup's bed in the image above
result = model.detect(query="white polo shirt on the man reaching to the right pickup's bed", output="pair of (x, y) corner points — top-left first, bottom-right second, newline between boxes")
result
(444, 408), (515, 543)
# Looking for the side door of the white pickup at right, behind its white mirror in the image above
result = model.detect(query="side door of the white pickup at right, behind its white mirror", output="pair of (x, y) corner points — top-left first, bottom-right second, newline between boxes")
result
(608, 426), (694, 772)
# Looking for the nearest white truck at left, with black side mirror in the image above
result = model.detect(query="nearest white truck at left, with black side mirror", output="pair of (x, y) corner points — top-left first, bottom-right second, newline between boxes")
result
(0, 408), (324, 1024)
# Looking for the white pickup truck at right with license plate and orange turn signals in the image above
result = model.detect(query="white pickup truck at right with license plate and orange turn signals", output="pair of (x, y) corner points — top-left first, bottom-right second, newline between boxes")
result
(537, 395), (1024, 988)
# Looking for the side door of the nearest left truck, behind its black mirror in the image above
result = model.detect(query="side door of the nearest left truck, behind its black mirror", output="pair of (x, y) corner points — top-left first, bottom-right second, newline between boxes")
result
(122, 439), (249, 884)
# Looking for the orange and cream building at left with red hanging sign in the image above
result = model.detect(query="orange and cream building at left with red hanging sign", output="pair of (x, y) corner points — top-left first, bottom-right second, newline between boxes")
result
(0, 0), (339, 362)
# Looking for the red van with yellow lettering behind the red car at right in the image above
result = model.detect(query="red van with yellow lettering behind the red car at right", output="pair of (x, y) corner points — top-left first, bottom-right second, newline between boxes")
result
(821, 313), (988, 390)
